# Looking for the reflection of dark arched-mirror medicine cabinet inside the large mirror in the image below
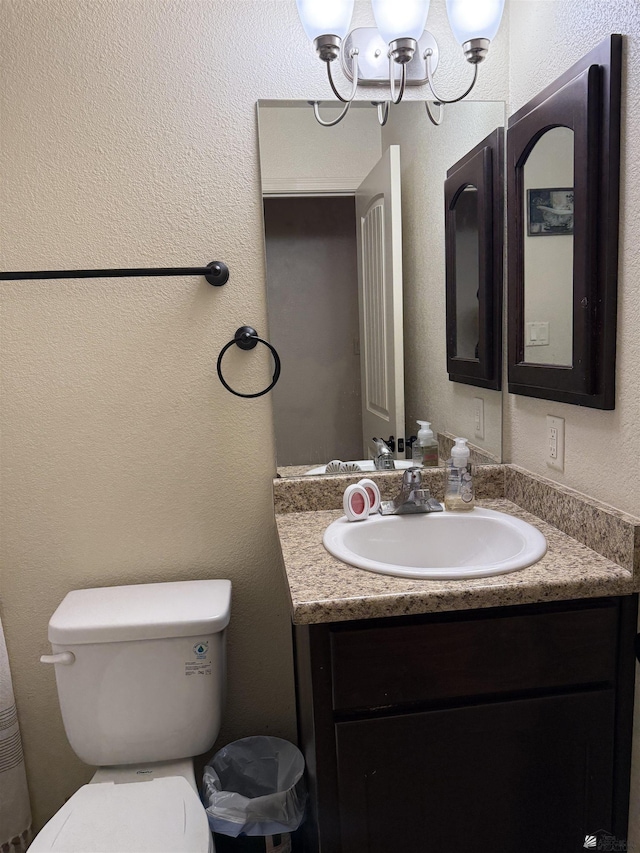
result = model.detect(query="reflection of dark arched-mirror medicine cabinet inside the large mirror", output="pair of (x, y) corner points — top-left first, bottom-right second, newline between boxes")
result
(444, 127), (504, 390)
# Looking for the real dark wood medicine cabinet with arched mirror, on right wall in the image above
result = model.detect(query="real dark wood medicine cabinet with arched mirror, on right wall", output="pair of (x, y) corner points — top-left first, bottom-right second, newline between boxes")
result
(507, 35), (622, 409)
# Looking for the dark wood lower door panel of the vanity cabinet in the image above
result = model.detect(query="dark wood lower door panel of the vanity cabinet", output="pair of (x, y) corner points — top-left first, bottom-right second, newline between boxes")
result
(335, 690), (615, 853)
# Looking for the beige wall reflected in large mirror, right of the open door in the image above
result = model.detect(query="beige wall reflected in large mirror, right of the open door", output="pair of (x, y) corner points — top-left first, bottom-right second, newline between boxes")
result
(382, 101), (505, 461)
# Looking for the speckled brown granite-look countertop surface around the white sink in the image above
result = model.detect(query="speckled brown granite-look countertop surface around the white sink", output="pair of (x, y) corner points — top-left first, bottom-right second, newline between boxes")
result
(276, 498), (637, 624)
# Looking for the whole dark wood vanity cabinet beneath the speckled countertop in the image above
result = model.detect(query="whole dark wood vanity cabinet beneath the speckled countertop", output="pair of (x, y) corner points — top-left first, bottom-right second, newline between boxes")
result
(294, 596), (637, 853)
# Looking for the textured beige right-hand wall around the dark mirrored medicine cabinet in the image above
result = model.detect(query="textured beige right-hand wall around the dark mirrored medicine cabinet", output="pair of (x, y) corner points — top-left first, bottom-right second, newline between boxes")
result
(505, 0), (640, 515)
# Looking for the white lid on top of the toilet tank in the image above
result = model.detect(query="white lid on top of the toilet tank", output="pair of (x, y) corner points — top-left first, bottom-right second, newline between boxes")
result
(49, 580), (231, 645)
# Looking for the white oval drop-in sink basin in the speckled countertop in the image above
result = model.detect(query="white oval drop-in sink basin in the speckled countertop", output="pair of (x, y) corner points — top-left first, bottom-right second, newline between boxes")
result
(323, 507), (547, 580)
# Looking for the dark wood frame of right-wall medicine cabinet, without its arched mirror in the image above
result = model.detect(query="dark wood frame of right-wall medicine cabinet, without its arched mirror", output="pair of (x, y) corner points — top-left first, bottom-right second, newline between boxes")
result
(507, 35), (622, 409)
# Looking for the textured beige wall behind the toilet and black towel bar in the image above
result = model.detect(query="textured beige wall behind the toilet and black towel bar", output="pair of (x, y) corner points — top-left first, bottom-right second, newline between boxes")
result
(0, 0), (504, 825)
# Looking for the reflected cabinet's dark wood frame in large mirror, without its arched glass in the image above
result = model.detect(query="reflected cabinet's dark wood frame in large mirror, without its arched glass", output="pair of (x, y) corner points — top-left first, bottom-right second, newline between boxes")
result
(444, 127), (504, 391)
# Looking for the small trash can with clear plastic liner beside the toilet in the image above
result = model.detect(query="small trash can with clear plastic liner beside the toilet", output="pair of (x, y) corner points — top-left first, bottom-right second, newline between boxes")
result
(202, 736), (307, 853)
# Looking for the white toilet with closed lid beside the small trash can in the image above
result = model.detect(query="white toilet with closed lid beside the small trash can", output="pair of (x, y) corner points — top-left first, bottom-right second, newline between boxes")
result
(30, 580), (231, 853)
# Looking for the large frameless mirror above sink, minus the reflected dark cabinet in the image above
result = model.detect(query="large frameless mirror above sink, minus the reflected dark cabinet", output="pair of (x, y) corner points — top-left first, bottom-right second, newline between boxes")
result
(258, 101), (505, 476)
